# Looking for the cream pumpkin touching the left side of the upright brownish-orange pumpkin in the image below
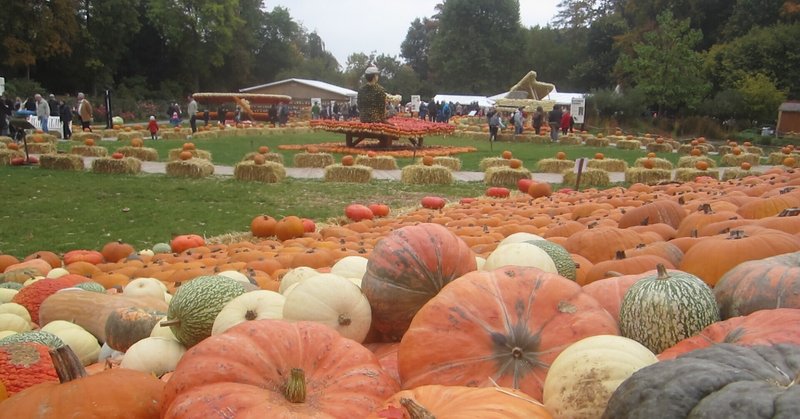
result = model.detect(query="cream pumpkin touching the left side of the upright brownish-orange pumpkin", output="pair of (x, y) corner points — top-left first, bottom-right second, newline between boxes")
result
(283, 274), (372, 342)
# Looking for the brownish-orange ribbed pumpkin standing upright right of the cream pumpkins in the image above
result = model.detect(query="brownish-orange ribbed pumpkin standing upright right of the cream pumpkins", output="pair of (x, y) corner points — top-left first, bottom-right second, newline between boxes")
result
(361, 223), (477, 341)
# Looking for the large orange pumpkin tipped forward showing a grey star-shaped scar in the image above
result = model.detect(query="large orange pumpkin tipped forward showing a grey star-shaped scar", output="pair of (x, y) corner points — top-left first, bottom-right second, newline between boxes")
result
(398, 266), (618, 400)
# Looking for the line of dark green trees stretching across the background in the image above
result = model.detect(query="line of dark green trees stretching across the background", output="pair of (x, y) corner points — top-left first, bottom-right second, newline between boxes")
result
(0, 0), (800, 126)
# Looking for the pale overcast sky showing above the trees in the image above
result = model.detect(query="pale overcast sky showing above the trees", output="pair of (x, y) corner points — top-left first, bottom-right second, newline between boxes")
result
(264, 0), (559, 67)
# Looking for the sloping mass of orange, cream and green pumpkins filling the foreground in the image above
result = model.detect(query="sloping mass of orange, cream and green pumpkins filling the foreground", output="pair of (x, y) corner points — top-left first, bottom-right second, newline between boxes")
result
(0, 170), (800, 418)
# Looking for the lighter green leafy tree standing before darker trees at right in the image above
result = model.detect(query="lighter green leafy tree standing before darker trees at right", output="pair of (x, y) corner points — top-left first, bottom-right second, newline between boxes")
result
(618, 11), (709, 115)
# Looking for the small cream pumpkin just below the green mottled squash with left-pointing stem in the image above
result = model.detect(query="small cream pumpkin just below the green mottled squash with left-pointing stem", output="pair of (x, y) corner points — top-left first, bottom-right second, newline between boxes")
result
(119, 337), (186, 377)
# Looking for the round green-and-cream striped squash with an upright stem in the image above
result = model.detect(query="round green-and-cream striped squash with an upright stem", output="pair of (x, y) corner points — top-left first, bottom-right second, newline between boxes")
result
(619, 264), (719, 354)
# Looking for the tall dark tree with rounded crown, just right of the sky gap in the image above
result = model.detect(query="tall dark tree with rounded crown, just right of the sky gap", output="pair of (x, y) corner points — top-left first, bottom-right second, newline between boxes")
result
(429, 0), (524, 94)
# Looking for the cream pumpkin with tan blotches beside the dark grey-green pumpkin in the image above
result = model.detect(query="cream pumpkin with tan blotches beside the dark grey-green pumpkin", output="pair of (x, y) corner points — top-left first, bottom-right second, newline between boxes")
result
(543, 335), (658, 418)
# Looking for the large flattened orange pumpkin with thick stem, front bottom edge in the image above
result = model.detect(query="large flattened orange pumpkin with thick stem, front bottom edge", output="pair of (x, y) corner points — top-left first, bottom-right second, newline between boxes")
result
(162, 320), (398, 419)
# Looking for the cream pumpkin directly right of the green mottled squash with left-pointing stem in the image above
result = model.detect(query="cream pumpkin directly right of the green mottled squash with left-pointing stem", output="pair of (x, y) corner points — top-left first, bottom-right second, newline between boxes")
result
(211, 290), (286, 336)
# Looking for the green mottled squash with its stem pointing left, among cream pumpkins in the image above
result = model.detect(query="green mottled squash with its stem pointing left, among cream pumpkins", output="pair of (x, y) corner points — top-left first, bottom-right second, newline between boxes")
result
(161, 275), (246, 348)
